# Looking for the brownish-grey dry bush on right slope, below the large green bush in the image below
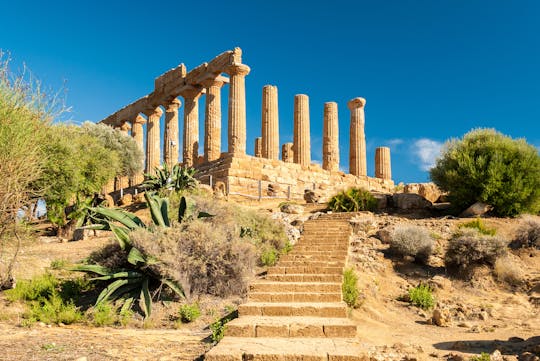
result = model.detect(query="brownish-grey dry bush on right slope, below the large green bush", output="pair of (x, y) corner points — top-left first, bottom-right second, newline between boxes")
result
(444, 228), (507, 269)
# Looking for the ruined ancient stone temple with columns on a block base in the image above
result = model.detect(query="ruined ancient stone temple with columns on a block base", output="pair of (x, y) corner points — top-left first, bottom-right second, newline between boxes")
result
(101, 48), (394, 199)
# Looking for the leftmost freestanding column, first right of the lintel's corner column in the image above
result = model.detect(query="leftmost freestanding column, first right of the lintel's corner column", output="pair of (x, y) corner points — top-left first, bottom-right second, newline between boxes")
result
(262, 85), (279, 159)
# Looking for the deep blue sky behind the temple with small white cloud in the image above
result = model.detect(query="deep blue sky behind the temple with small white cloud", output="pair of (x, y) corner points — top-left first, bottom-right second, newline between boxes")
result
(0, 0), (540, 182)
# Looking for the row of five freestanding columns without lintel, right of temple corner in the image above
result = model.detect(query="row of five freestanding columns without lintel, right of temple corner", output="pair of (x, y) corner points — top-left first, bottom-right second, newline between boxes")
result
(255, 89), (391, 179)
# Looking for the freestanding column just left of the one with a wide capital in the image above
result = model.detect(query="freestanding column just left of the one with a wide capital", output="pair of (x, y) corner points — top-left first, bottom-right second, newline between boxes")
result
(323, 102), (339, 172)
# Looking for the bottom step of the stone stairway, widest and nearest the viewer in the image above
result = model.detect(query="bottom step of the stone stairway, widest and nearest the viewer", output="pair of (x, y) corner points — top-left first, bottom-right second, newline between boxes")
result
(204, 337), (367, 361)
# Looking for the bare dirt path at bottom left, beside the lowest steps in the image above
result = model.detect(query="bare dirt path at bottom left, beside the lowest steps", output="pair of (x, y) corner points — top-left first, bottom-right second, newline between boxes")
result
(0, 323), (210, 361)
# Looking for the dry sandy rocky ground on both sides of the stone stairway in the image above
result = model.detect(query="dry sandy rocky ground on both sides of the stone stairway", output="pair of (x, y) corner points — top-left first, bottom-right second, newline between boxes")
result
(0, 204), (540, 361)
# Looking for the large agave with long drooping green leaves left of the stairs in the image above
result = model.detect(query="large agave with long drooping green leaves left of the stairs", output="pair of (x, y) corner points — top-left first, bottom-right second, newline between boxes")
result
(71, 192), (190, 317)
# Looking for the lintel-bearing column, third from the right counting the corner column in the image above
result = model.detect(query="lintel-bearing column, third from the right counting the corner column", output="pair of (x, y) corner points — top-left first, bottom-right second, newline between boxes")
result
(182, 89), (201, 167)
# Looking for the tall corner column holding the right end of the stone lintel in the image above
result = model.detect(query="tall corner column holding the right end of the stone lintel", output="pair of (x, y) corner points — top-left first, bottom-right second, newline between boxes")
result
(226, 63), (250, 155)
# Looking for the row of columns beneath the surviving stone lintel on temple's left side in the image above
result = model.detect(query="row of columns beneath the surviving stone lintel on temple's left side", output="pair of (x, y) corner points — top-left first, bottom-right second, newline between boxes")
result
(119, 64), (250, 173)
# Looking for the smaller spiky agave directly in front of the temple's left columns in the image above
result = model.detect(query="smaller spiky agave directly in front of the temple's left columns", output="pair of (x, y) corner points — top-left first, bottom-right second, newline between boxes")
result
(142, 163), (197, 192)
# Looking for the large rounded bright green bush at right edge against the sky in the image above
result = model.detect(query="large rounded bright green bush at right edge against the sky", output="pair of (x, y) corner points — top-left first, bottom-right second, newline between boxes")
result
(430, 129), (540, 216)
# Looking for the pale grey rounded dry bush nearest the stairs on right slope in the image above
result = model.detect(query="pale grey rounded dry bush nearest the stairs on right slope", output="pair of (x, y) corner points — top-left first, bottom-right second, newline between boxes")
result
(390, 225), (434, 262)
